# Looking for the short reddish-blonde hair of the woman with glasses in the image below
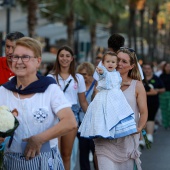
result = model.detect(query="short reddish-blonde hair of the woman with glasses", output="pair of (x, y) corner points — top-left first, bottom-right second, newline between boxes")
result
(15, 37), (42, 57)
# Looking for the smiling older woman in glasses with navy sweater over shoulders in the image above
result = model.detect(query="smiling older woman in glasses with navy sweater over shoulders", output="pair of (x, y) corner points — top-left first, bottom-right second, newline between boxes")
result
(0, 37), (77, 170)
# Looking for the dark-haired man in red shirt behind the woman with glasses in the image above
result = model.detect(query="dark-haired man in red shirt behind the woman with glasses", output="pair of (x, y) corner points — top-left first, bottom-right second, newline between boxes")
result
(0, 32), (24, 85)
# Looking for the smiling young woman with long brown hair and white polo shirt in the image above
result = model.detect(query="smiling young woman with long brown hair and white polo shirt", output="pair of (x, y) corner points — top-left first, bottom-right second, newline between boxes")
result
(48, 46), (88, 170)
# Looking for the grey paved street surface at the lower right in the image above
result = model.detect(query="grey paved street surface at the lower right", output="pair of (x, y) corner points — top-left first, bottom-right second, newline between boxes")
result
(75, 127), (170, 170)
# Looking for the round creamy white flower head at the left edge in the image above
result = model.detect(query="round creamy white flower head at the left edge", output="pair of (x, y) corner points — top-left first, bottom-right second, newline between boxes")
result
(0, 106), (15, 132)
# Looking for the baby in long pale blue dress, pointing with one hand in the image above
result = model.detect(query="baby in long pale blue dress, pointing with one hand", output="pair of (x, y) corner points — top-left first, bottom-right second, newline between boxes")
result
(78, 51), (137, 139)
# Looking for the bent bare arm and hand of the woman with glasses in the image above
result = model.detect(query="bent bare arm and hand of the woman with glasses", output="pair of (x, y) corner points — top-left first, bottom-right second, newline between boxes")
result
(24, 108), (77, 160)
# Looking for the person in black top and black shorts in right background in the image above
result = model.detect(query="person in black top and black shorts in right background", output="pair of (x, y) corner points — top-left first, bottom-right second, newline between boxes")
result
(142, 63), (165, 143)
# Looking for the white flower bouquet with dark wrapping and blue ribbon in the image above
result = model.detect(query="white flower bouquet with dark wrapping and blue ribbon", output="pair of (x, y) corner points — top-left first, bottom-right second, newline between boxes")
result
(0, 106), (19, 170)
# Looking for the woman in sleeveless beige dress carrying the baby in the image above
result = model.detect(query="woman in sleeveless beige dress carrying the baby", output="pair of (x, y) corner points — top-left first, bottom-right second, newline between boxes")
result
(94, 47), (148, 170)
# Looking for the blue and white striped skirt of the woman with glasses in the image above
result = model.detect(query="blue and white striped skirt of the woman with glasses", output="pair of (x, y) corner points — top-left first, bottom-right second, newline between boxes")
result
(4, 147), (64, 170)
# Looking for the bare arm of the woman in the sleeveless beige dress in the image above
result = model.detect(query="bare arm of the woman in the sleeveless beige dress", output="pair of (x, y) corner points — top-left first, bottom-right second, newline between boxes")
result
(136, 81), (148, 132)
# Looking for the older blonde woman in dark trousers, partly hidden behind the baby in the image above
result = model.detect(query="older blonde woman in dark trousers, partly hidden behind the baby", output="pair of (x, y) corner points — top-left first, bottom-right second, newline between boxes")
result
(77, 62), (97, 170)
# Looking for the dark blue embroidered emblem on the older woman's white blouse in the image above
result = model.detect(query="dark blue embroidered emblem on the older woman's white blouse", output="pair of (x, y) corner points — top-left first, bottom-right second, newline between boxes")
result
(33, 108), (48, 123)
